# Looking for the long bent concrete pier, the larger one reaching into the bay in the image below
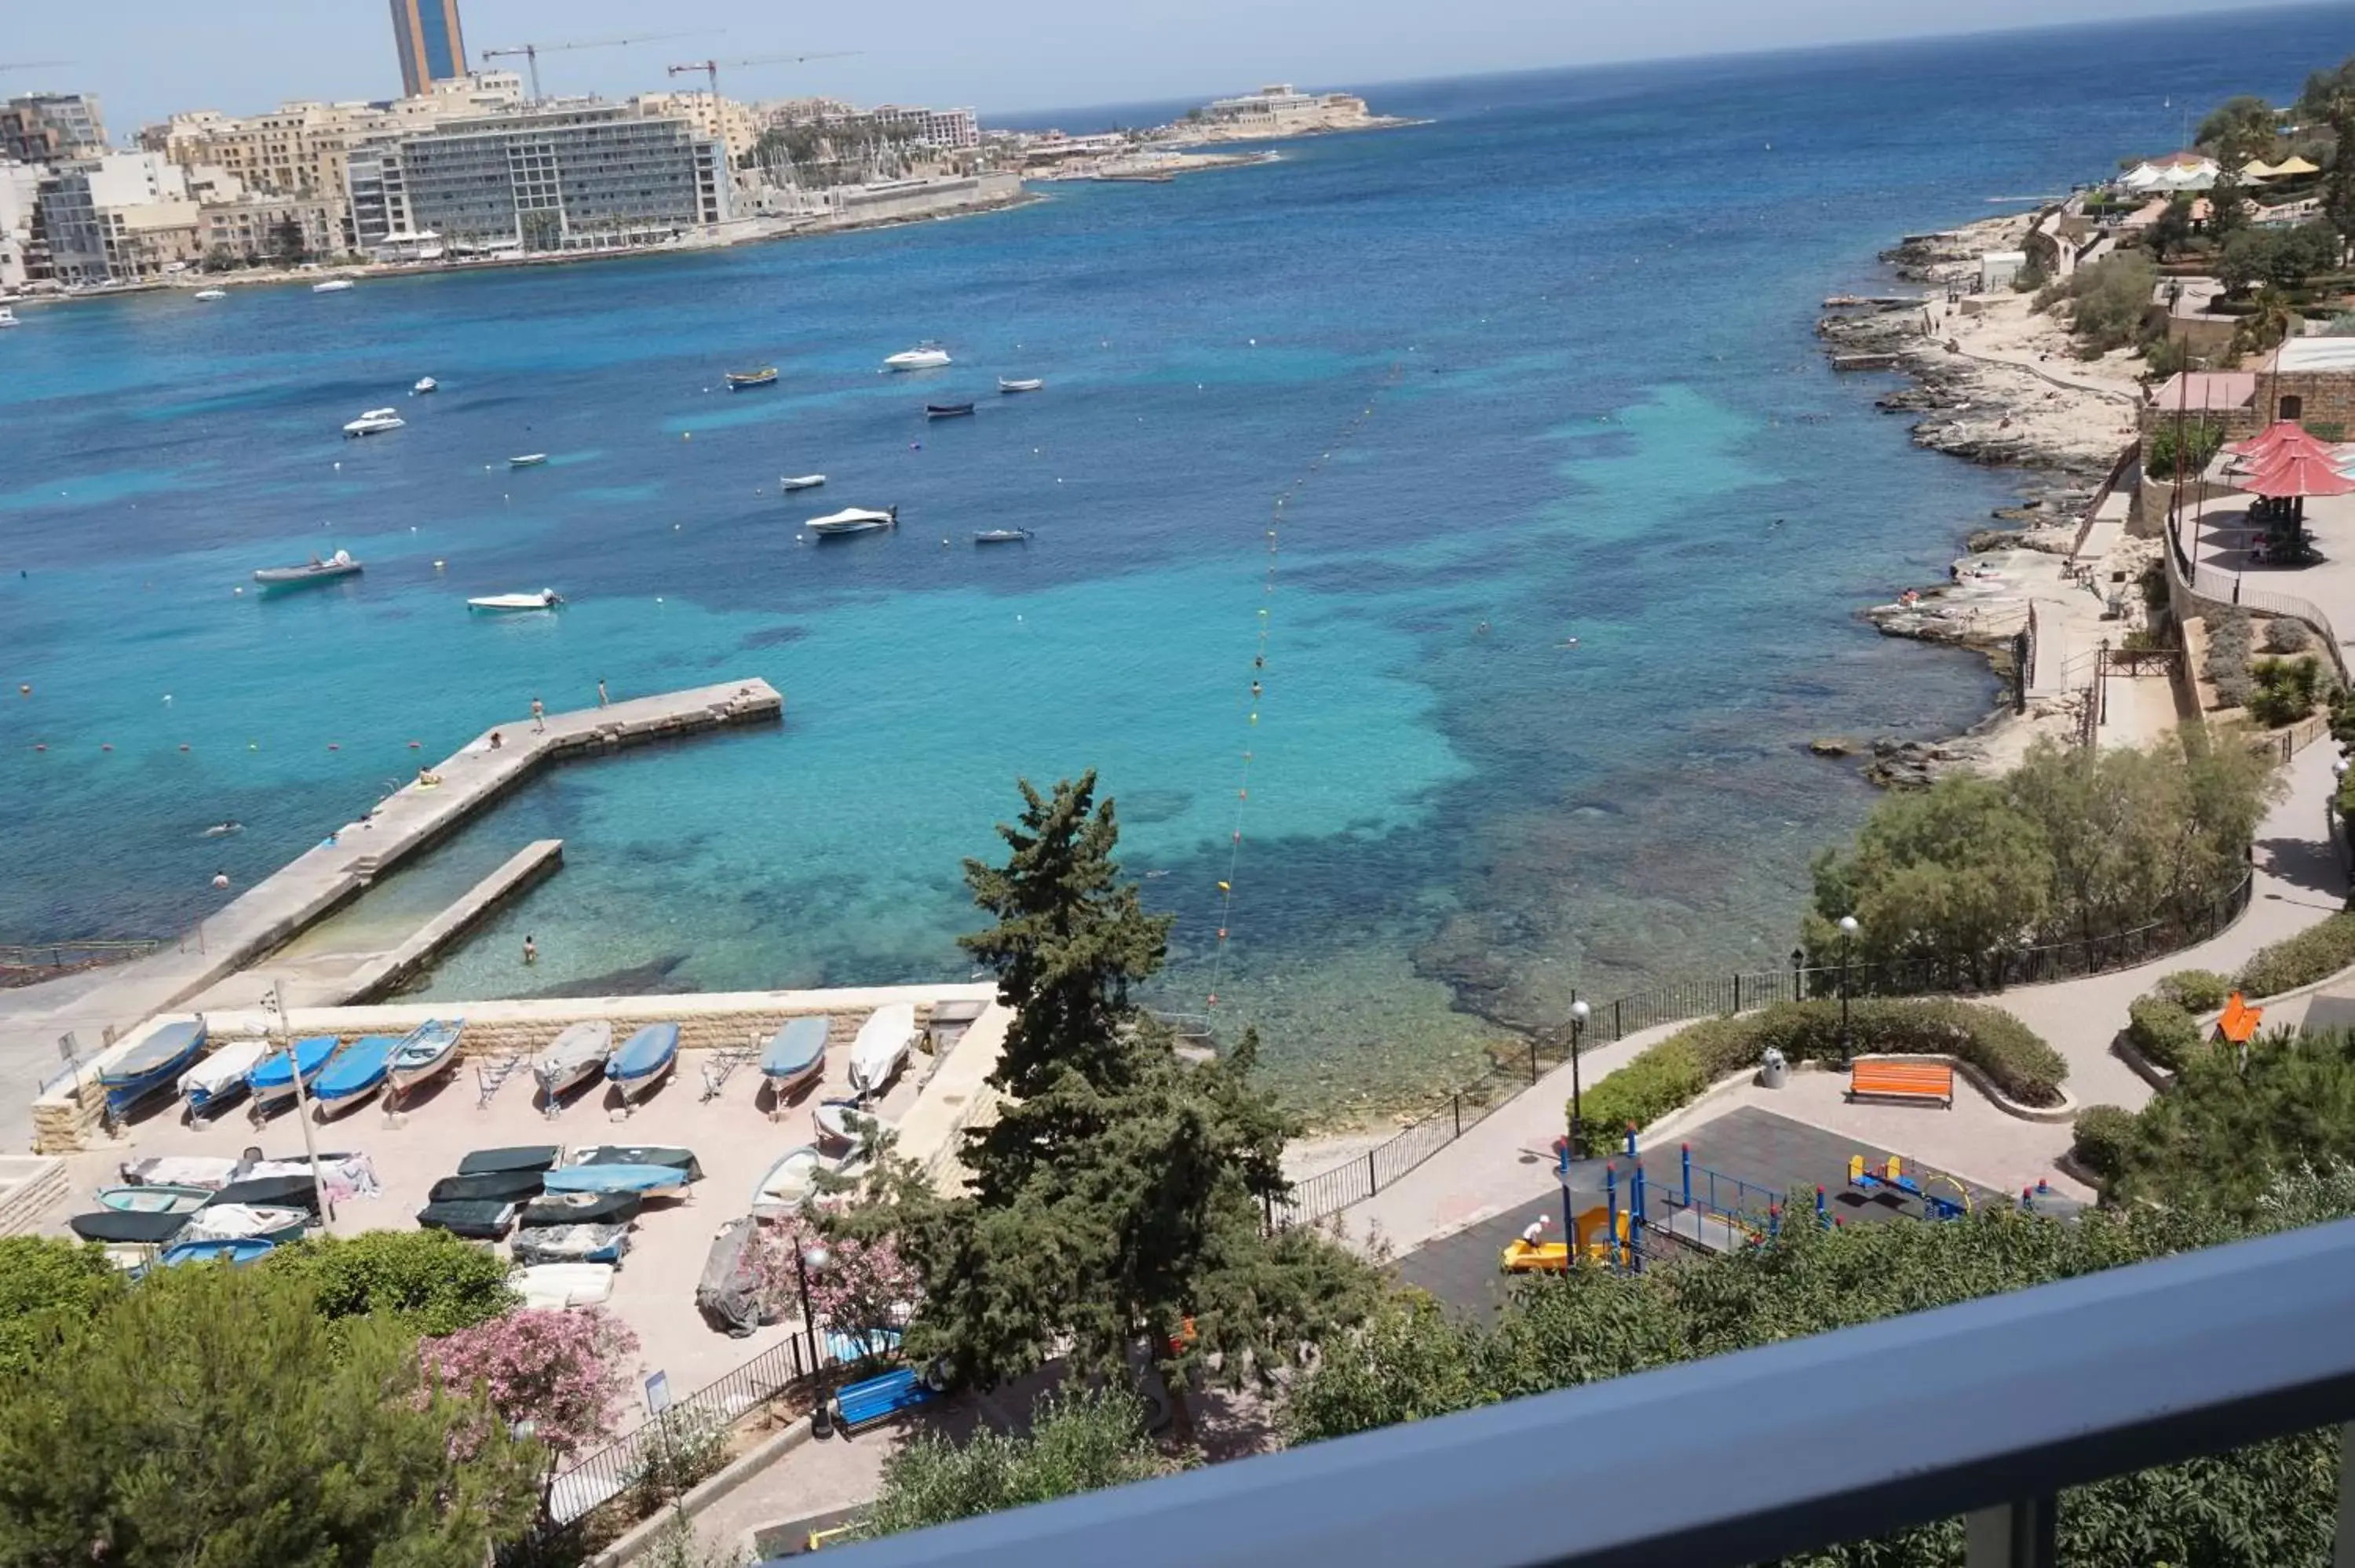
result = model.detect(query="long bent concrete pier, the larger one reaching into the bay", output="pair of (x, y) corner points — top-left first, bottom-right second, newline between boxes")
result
(0, 680), (784, 1147)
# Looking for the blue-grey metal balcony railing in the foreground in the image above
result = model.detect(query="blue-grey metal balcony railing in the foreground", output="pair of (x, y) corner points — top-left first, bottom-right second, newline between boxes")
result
(801, 1220), (2355, 1568)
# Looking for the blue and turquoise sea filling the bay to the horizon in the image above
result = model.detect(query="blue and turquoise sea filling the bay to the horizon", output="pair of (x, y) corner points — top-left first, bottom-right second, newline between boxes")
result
(0, 7), (2355, 1109)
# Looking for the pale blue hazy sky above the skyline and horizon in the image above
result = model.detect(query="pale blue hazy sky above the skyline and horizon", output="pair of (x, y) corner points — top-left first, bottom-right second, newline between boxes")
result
(0, 0), (2346, 141)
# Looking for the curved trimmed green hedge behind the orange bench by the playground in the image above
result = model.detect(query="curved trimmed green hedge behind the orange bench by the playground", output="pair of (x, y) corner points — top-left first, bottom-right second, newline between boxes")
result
(1564, 996), (2068, 1144)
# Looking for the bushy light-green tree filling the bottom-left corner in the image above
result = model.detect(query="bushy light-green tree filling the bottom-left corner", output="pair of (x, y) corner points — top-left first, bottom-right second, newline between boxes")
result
(0, 1264), (544, 1568)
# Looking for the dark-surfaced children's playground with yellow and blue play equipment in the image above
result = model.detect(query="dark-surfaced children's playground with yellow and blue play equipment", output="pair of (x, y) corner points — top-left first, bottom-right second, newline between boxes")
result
(1399, 1107), (2075, 1311)
